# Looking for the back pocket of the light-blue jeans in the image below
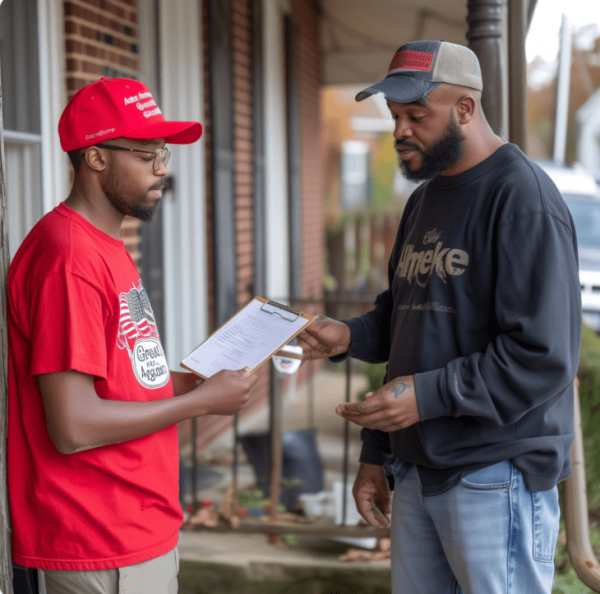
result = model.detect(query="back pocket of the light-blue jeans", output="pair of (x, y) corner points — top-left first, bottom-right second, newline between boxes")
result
(531, 487), (560, 563)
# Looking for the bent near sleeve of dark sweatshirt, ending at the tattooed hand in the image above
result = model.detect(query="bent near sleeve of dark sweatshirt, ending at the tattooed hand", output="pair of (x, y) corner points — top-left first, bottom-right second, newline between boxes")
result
(415, 212), (581, 425)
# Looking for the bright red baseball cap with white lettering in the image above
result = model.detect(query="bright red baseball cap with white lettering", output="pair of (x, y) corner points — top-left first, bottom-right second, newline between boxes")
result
(58, 78), (202, 152)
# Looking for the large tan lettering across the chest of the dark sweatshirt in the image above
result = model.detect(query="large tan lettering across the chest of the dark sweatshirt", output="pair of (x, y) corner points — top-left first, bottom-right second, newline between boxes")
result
(396, 229), (469, 287)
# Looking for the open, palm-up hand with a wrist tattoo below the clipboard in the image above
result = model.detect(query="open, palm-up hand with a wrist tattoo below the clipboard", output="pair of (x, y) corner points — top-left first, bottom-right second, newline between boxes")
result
(335, 375), (421, 431)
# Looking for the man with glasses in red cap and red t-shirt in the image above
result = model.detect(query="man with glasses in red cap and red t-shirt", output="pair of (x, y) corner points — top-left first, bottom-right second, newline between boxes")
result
(8, 79), (256, 594)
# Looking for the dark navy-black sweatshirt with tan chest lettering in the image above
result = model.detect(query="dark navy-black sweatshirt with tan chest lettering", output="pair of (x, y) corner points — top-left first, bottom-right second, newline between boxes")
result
(346, 144), (581, 495)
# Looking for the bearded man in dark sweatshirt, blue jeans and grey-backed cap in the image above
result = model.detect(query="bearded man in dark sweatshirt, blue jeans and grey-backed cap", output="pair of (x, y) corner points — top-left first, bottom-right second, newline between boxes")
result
(300, 41), (581, 594)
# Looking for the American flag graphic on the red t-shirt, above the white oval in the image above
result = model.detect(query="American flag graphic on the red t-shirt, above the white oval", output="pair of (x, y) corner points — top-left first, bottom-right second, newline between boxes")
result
(117, 280), (159, 356)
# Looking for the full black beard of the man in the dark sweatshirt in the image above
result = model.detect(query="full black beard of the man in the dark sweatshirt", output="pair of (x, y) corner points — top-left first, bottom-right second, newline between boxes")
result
(394, 112), (465, 181)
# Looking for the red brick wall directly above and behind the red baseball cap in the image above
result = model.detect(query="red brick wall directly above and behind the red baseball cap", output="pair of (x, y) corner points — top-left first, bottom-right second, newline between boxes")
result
(64, 0), (140, 265)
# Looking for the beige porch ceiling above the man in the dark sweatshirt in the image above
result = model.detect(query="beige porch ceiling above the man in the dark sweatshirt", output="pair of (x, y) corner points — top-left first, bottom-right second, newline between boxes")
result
(320, 0), (467, 85)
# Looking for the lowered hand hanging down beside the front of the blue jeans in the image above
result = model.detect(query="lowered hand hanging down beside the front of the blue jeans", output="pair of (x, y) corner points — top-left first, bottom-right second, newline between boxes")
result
(352, 462), (390, 528)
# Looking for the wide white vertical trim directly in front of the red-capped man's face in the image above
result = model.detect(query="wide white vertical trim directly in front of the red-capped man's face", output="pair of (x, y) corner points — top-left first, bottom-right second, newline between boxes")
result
(158, 0), (208, 369)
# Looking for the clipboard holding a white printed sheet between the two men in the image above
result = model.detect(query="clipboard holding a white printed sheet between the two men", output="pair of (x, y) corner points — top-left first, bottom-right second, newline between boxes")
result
(180, 295), (315, 379)
